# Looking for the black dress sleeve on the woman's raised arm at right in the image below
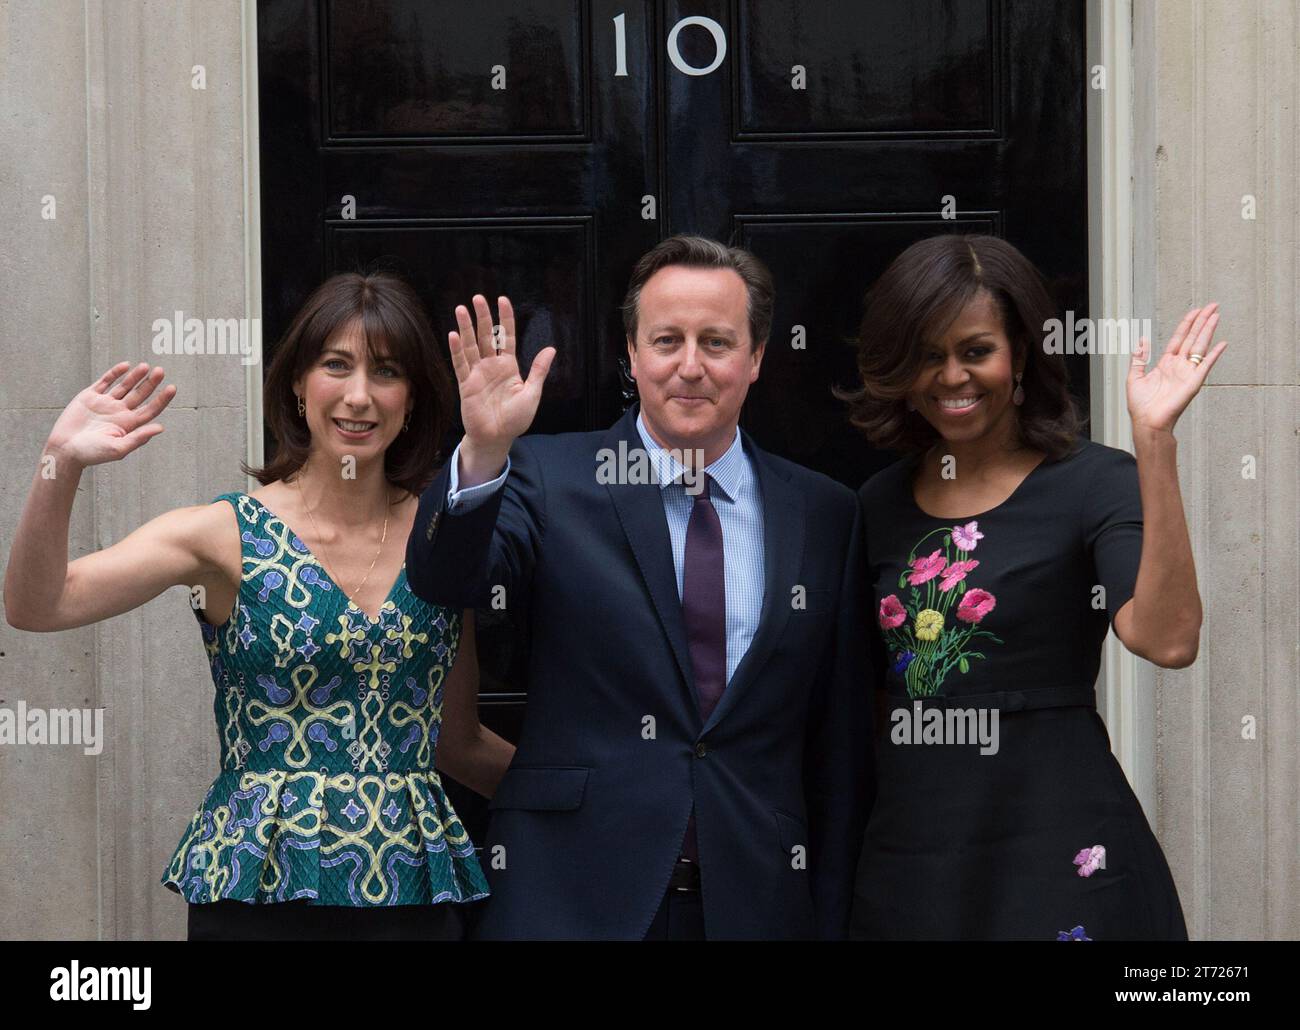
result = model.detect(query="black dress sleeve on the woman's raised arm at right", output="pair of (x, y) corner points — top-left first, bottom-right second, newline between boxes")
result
(1079, 443), (1143, 624)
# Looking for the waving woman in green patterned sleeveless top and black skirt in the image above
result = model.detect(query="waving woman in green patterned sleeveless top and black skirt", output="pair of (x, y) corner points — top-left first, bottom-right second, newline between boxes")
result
(5, 273), (514, 940)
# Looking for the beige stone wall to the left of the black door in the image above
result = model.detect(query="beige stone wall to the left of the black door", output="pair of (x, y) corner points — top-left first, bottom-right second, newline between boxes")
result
(0, 0), (247, 939)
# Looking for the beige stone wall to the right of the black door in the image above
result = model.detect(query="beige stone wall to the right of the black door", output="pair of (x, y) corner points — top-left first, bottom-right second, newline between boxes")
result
(1134, 0), (1300, 939)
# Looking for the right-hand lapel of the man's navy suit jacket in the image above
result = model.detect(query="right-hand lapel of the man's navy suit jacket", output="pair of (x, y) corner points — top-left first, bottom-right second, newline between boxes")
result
(702, 430), (803, 733)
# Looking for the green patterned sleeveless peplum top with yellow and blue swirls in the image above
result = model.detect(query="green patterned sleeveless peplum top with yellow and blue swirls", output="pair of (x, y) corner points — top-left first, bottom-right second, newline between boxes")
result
(163, 493), (488, 908)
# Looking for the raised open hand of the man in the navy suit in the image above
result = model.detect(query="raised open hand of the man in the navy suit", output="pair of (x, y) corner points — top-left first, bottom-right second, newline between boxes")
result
(447, 294), (555, 454)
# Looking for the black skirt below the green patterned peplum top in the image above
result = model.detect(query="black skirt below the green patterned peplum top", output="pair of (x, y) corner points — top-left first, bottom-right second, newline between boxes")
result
(187, 900), (465, 940)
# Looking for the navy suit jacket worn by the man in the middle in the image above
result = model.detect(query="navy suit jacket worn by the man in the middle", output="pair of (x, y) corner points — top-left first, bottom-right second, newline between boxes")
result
(407, 407), (874, 939)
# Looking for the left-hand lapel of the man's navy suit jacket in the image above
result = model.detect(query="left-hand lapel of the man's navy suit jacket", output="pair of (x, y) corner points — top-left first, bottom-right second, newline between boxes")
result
(593, 406), (696, 707)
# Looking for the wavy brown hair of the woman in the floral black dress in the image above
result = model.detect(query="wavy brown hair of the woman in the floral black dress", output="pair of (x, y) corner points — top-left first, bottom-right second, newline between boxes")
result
(837, 234), (1083, 460)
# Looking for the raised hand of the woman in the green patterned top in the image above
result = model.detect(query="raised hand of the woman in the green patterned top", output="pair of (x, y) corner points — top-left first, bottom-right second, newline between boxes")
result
(46, 362), (176, 467)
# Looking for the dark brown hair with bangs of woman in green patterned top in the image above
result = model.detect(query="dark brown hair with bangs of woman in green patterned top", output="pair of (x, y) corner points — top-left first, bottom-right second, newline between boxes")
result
(241, 272), (451, 494)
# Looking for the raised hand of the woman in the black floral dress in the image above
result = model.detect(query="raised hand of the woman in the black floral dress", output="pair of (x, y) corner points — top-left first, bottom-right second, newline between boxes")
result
(1128, 303), (1227, 432)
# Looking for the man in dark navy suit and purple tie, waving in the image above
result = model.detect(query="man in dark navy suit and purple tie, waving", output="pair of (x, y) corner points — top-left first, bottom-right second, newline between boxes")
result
(407, 237), (872, 939)
